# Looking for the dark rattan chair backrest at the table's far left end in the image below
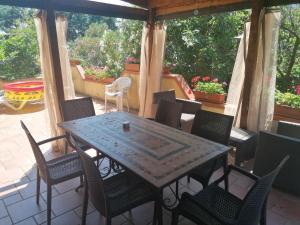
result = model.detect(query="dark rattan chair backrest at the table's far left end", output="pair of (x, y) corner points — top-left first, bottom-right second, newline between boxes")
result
(61, 97), (96, 121)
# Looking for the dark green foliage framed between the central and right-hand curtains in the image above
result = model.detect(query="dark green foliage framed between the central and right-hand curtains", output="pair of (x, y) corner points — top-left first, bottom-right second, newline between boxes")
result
(166, 11), (249, 84)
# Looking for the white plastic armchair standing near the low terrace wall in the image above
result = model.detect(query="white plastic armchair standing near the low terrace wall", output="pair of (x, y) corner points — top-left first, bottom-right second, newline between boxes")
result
(105, 77), (131, 112)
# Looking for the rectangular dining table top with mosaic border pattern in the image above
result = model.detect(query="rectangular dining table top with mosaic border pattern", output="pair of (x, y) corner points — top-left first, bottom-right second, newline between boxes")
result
(59, 112), (230, 188)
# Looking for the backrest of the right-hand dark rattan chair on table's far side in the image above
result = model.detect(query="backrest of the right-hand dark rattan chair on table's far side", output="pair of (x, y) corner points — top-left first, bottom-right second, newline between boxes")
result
(191, 110), (233, 145)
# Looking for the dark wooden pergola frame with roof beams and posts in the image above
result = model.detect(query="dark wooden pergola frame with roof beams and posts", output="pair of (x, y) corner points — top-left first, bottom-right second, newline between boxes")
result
(0, 0), (299, 128)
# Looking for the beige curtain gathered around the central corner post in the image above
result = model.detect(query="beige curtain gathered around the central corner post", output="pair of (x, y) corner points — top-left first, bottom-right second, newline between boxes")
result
(139, 23), (166, 118)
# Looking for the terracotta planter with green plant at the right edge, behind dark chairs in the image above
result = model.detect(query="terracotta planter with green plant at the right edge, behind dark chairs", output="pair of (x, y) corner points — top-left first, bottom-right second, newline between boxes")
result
(275, 90), (300, 120)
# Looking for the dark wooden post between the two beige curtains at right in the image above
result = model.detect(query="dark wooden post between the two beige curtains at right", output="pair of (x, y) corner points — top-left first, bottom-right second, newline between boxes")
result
(241, 0), (264, 129)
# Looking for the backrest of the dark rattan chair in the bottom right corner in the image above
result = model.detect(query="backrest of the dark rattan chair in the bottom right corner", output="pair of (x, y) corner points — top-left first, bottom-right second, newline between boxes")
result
(237, 155), (290, 225)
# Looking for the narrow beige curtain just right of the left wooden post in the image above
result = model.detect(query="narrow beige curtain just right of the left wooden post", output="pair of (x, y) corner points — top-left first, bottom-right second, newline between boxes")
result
(56, 15), (75, 100)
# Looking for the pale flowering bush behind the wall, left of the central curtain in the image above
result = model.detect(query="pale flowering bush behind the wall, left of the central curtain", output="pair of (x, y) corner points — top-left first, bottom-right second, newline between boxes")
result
(71, 20), (142, 77)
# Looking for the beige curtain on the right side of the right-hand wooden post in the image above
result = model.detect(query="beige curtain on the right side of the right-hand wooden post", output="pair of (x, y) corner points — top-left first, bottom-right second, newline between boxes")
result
(247, 12), (281, 132)
